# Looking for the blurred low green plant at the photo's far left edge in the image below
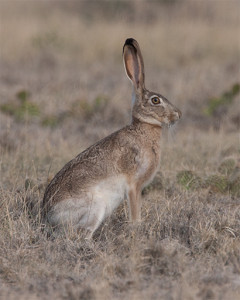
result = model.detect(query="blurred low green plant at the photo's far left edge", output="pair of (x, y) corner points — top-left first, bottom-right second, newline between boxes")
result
(0, 90), (40, 121)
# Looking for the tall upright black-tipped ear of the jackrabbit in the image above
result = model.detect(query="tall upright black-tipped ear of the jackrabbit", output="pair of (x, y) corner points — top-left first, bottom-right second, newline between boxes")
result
(123, 38), (145, 91)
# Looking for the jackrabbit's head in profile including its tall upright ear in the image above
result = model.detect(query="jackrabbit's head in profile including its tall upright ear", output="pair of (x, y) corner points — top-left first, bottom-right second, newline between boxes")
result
(123, 38), (182, 126)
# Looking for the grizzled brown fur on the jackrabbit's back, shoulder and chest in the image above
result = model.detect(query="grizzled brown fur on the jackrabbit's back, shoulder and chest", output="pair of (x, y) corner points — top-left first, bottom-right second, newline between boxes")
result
(43, 120), (161, 213)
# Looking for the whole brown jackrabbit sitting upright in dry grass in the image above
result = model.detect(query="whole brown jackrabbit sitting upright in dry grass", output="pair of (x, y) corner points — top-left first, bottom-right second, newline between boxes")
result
(42, 38), (181, 238)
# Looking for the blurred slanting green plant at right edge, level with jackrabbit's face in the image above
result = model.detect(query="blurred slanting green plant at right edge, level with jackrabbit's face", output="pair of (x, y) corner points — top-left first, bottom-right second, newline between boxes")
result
(204, 83), (240, 116)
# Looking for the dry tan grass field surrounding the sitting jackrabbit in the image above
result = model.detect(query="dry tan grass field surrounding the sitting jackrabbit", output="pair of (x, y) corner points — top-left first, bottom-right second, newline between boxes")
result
(0, 1), (240, 300)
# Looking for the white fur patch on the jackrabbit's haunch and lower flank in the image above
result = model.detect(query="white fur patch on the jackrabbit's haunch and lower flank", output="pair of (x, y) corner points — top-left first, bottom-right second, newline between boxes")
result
(48, 176), (128, 231)
